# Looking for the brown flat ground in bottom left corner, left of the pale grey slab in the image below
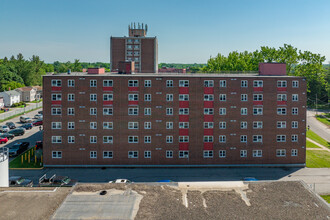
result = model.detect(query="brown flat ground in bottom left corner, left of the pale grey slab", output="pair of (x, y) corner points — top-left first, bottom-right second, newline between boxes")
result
(0, 187), (72, 220)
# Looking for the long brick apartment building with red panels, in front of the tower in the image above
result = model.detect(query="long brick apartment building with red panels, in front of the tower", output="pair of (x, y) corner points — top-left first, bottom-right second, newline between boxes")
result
(43, 64), (306, 166)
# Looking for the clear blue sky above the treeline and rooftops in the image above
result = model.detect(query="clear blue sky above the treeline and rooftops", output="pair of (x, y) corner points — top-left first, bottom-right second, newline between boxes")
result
(0, 0), (330, 63)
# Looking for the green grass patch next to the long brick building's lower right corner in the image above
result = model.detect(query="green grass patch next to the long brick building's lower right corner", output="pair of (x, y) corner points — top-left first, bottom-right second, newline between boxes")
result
(306, 150), (330, 168)
